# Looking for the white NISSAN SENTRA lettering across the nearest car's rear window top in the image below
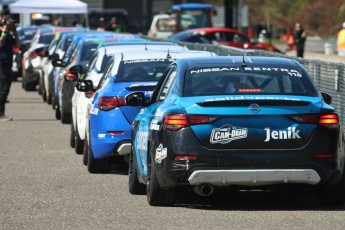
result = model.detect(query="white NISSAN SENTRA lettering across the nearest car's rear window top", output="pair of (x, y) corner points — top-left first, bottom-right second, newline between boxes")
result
(190, 67), (302, 77)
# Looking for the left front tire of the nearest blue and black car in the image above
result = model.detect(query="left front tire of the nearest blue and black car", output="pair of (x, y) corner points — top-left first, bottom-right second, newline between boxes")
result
(128, 153), (146, 195)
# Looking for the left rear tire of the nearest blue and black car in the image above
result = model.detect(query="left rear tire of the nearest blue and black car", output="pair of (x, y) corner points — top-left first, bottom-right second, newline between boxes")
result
(146, 152), (175, 206)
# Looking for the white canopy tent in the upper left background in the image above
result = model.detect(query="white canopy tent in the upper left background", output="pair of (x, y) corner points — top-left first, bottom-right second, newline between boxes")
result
(9, 0), (89, 27)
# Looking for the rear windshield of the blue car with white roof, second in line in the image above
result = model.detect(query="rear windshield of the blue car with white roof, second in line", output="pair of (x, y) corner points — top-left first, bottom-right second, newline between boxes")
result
(116, 59), (173, 82)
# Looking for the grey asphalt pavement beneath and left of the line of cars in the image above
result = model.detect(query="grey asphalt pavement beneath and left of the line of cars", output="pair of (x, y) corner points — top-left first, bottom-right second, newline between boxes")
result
(0, 77), (345, 230)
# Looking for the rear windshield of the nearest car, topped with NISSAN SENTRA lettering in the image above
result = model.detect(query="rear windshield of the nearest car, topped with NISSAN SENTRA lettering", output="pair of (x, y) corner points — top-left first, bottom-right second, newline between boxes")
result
(184, 67), (315, 97)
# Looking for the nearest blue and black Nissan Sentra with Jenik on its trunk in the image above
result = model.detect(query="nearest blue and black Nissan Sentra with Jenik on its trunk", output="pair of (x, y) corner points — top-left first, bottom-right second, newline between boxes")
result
(125, 57), (345, 206)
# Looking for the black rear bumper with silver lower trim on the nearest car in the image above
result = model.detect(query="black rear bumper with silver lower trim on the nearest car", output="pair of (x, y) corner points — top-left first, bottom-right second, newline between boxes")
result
(151, 129), (344, 188)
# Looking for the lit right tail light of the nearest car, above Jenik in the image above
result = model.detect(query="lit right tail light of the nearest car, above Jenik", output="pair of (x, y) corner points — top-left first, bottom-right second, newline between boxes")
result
(293, 113), (339, 125)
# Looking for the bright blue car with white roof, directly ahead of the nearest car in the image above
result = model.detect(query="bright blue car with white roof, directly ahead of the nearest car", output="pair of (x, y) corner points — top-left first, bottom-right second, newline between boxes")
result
(86, 49), (214, 173)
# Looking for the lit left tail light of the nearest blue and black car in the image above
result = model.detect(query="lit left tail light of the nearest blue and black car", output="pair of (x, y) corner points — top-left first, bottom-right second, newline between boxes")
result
(163, 114), (217, 131)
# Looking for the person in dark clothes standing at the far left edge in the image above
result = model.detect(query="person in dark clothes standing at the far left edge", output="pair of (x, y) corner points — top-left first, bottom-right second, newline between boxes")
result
(0, 12), (20, 122)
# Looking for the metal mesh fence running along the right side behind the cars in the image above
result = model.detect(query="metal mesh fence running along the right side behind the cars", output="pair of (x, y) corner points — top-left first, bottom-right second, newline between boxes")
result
(160, 40), (345, 131)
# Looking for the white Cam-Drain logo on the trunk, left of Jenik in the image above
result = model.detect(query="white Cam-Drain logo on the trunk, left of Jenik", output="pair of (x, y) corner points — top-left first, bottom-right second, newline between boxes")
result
(210, 125), (248, 144)
